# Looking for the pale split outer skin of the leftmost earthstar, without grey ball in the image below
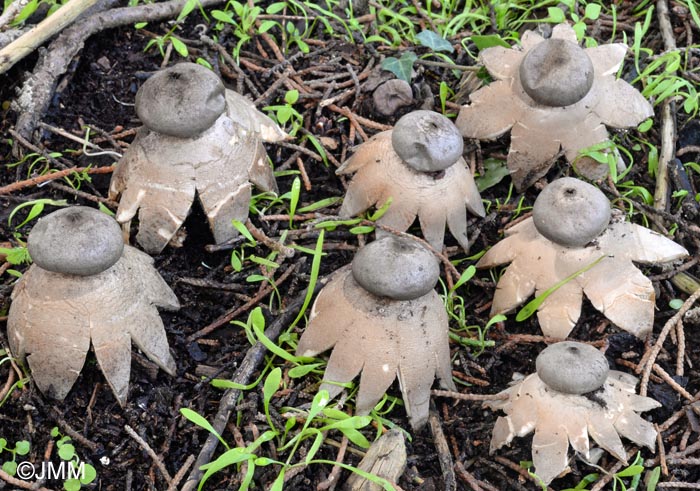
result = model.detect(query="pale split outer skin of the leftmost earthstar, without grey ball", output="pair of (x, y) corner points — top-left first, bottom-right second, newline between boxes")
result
(7, 246), (180, 406)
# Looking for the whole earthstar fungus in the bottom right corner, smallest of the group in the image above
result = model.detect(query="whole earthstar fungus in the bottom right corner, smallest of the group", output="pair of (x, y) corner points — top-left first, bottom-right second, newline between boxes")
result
(485, 341), (661, 484)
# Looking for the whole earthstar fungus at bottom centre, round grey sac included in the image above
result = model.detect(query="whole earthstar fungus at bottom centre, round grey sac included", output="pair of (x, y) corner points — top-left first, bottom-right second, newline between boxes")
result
(297, 236), (454, 429)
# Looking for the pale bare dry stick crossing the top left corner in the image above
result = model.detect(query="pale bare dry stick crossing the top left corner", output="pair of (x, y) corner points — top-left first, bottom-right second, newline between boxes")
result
(0, 0), (97, 74)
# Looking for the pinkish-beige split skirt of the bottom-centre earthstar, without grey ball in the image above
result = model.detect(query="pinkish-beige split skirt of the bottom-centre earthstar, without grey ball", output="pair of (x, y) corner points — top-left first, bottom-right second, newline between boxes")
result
(296, 267), (455, 429)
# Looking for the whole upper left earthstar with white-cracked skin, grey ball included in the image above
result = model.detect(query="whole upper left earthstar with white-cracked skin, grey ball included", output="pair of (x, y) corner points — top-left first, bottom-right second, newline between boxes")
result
(110, 63), (287, 254)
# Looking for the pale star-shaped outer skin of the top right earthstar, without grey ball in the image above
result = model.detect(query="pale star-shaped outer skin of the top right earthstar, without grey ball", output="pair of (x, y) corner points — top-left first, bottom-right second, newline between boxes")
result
(455, 24), (654, 191)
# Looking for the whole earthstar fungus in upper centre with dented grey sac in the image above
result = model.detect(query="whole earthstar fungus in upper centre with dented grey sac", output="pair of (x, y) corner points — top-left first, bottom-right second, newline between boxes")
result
(336, 111), (484, 250)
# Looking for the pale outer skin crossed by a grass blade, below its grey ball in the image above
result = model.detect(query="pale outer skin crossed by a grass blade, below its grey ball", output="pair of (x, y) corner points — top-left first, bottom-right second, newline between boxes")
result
(476, 213), (688, 339)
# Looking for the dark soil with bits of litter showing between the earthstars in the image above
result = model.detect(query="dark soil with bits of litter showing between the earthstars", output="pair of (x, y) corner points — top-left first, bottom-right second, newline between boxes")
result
(0, 3), (700, 491)
